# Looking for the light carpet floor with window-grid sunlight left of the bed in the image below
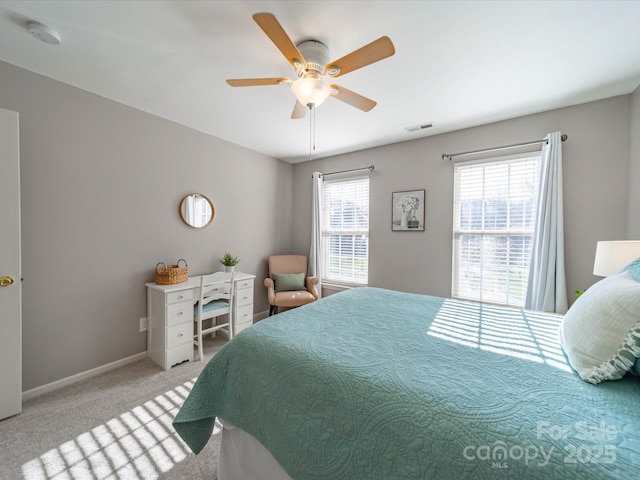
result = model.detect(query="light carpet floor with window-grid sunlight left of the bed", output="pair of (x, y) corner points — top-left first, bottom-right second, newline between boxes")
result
(0, 337), (226, 480)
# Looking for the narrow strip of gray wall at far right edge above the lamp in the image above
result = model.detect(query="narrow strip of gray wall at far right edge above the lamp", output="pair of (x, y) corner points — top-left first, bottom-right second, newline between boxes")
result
(629, 87), (640, 240)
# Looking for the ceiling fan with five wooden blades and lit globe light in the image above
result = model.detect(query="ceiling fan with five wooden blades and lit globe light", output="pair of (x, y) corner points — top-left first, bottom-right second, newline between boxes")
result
(227, 13), (395, 119)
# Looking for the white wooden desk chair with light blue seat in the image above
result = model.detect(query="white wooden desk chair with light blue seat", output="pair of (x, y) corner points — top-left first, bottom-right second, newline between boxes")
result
(193, 272), (235, 361)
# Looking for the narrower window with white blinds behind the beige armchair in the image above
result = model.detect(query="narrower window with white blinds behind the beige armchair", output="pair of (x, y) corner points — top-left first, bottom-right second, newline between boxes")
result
(322, 177), (369, 285)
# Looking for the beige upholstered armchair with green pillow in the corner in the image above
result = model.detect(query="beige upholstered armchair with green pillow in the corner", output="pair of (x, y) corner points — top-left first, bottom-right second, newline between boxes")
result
(264, 255), (319, 315)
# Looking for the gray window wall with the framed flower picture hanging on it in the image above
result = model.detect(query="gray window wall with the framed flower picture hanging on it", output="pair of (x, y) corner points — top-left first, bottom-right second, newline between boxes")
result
(293, 93), (640, 302)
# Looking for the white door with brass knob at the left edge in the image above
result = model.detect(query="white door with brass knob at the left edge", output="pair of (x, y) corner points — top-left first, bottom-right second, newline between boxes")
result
(0, 108), (22, 419)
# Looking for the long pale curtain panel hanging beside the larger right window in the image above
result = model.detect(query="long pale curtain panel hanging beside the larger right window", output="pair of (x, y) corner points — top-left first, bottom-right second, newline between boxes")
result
(525, 132), (568, 313)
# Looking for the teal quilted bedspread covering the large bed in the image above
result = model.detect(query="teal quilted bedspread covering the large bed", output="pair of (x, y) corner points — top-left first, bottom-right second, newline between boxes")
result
(173, 288), (640, 480)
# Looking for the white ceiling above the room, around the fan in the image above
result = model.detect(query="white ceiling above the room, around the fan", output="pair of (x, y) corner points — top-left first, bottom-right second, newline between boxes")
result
(0, 0), (640, 163)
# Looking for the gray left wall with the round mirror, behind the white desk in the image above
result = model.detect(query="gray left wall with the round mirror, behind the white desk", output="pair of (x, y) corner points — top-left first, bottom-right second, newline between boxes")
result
(0, 62), (292, 390)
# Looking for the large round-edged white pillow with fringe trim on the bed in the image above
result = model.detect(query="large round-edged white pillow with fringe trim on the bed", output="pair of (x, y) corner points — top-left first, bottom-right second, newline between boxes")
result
(560, 272), (640, 384)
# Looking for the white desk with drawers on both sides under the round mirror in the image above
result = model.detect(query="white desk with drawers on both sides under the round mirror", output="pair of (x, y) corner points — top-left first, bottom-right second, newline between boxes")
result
(146, 272), (255, 370)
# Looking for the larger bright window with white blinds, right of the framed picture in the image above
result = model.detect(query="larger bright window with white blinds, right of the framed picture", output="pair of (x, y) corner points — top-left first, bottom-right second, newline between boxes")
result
(452, 154), (540, 307)
